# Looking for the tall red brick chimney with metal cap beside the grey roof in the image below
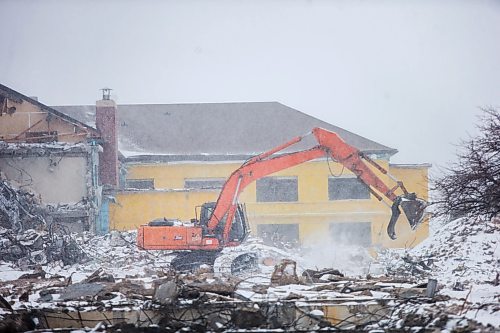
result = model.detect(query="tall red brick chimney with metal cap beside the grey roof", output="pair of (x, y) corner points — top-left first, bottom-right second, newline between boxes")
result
(95, 88), (118, 187)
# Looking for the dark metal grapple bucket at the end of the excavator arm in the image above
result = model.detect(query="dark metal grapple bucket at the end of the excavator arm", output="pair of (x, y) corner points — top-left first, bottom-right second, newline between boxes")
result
(387, 193), (428, 239)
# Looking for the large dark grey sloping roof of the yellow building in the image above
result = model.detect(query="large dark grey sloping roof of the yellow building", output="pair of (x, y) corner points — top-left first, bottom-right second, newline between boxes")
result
(53, 102), (397, 160)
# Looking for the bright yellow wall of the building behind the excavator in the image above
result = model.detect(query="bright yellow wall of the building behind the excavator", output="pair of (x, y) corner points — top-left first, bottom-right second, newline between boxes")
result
(110, 160), (428, 247)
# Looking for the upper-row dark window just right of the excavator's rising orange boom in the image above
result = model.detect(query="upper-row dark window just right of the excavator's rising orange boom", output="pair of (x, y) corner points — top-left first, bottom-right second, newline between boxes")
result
(257, 177), (299, 202)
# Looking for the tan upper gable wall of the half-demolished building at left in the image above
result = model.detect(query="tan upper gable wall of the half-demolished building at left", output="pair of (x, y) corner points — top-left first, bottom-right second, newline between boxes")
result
(0, 99), (89, 143)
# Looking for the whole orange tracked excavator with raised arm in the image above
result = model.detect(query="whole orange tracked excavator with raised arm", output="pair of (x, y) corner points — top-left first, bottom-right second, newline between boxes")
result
(137, 127), (427, 273)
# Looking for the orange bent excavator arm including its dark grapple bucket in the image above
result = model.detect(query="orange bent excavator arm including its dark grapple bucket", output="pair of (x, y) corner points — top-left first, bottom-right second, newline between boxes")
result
(207, 127), (427, 244)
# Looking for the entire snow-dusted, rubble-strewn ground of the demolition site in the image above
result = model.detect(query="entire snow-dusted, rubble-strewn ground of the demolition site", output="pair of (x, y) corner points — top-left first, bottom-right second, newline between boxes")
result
(0, 183), (500, 332)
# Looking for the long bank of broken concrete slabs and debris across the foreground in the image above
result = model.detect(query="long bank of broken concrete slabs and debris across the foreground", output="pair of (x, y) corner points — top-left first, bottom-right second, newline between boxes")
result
(0, 260), (494, 332)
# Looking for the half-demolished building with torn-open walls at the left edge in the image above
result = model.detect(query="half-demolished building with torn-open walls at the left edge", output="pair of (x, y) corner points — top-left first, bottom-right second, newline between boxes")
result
(0, 85), (101, 231)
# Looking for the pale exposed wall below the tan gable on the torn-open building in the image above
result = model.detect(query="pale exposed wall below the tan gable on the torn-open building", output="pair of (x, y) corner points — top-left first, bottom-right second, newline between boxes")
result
(0, 142), (100, 231)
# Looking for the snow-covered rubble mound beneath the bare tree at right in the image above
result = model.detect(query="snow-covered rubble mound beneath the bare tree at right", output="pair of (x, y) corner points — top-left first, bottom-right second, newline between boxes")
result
(379, 218), (500, 328)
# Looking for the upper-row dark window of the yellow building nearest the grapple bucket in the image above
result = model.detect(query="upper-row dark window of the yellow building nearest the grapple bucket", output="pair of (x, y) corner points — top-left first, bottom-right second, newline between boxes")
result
(328, 177), (370, 200)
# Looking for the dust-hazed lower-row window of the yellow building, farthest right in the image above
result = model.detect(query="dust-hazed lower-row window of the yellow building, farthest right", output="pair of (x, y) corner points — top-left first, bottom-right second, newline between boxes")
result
(330, 222), (372, 247)
